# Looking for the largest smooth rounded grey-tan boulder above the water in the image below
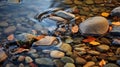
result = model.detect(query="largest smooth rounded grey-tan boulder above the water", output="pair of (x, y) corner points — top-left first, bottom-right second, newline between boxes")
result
(79, 16), (109, 34)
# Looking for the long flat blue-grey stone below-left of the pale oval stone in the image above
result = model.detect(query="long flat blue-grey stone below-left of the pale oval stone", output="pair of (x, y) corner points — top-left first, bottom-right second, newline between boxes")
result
(35, 58), (54, 65)
